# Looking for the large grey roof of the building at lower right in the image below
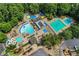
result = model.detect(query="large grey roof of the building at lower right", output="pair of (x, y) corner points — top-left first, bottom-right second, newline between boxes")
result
(60, 39), (79, 50)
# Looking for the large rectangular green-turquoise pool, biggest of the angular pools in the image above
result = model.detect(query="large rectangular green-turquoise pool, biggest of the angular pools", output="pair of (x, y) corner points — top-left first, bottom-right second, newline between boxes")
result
(50, 19), (65, 32)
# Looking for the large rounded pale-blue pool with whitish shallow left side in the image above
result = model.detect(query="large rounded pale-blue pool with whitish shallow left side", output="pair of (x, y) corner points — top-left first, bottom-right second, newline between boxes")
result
(20, 23), (34, 35)
